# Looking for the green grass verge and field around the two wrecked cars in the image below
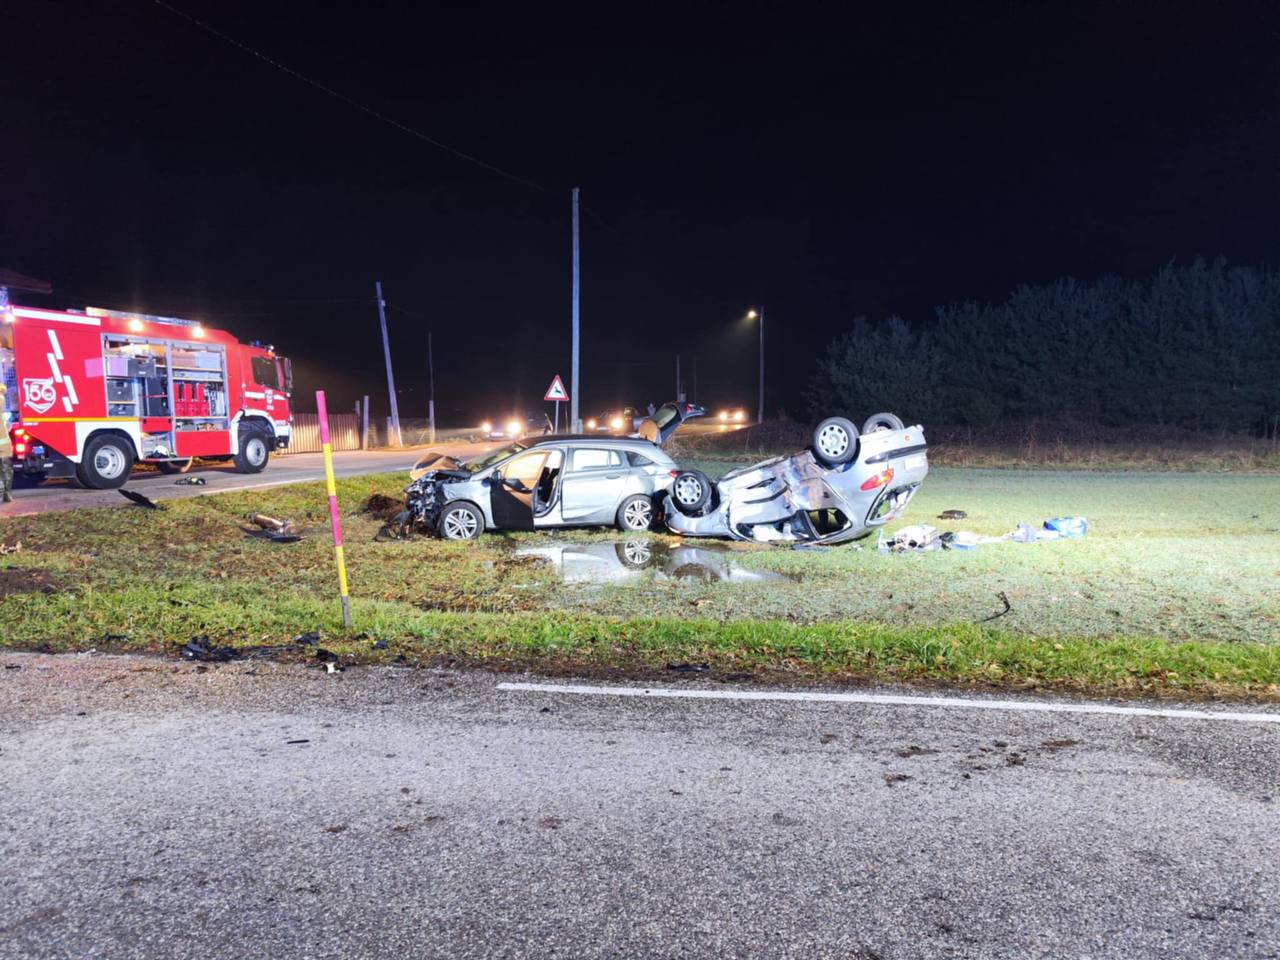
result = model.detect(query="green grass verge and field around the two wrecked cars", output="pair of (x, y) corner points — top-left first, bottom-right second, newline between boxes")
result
(0, 465), (1280, 700)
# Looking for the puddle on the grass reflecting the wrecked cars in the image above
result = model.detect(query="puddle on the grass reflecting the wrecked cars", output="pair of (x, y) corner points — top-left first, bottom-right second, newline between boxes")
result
(516, 538), (790, 584)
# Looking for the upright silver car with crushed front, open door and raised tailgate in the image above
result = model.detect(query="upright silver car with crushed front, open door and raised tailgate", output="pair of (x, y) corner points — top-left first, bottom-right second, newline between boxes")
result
(394, 403), (704, 540)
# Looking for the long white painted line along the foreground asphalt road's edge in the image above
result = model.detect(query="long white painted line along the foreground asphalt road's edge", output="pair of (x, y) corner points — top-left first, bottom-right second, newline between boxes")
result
(498, 684), (1280, 723)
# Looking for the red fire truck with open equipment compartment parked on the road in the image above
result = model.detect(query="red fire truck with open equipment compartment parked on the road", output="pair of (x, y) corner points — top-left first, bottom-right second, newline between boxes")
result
(0, 306), (293, 489)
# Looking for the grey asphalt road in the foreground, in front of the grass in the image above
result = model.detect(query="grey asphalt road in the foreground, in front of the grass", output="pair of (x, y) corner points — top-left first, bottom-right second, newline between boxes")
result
(0, 654), (1280, 960)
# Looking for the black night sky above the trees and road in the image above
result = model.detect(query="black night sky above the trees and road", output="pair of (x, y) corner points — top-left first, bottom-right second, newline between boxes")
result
(0, 0), (1280, 421)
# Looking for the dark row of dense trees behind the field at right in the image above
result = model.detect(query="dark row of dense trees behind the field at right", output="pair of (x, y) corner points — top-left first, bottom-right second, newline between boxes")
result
(809, 260), (1280, 433)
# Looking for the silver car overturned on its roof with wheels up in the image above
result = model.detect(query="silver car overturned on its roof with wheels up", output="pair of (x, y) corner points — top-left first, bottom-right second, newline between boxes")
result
(664, 413), (929, 543)
